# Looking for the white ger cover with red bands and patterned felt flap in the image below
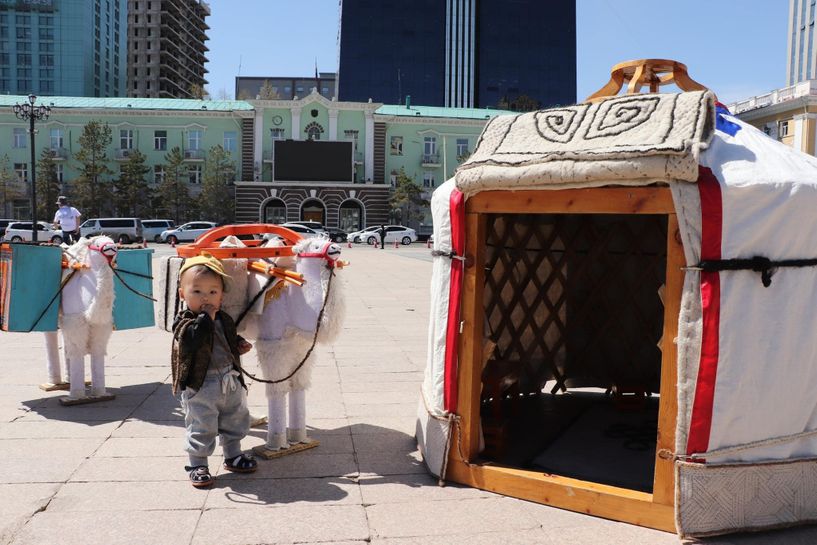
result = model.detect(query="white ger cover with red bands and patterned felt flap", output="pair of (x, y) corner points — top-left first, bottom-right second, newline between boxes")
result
(418, 92), (817, 535)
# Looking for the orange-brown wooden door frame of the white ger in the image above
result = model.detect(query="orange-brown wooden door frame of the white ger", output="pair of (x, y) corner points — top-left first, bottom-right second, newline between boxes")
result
(447, 187), (684, 531)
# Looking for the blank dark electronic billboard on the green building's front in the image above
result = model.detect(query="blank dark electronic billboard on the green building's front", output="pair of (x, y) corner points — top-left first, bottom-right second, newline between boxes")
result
(272, 140), (355, 182)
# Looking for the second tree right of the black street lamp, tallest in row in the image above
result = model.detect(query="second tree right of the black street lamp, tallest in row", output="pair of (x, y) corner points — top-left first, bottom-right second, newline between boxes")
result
(73, 121), (113, 217)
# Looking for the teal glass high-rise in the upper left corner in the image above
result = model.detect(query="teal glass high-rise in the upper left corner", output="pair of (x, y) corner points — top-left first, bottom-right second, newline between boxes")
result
(0, 0), (127, 97)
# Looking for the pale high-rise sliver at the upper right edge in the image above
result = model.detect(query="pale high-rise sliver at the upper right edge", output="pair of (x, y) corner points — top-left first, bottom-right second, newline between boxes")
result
(786, 0), (817, 86)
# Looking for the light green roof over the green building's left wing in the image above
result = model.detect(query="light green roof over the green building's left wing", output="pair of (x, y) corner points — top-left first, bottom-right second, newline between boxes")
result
(0, 95), (253, 112)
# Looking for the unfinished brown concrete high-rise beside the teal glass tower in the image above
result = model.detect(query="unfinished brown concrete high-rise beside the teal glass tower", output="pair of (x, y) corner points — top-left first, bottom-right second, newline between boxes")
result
(127, 0), (210, 98)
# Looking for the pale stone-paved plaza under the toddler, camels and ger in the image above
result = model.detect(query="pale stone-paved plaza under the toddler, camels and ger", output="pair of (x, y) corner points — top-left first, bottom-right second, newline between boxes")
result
(0, 244), (817, 545)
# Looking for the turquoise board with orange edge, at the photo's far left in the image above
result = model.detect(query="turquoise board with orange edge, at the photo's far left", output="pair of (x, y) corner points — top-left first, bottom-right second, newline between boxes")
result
(0, 244), (62, 331)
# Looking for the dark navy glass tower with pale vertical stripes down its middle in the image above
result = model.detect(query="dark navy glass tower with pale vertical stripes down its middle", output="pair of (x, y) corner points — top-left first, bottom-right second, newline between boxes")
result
(338, 0), (576, 108)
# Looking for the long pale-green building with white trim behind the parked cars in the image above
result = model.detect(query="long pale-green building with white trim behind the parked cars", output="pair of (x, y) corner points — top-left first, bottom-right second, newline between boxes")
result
(0, 91), (509, 234)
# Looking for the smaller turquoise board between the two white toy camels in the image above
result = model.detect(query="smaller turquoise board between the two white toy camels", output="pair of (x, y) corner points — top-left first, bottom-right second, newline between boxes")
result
(113, 248), (154, 330)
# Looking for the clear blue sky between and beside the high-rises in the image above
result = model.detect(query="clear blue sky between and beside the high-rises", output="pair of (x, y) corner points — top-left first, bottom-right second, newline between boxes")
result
(206, 0), (789, 104)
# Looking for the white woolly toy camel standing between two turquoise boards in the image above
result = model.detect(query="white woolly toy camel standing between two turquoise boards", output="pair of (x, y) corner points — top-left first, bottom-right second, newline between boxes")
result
(60, 236), (117, 404)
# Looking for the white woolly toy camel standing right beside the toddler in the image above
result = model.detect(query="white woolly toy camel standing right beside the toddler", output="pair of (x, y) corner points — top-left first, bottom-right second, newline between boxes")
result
(251, 238), (343, 455)
